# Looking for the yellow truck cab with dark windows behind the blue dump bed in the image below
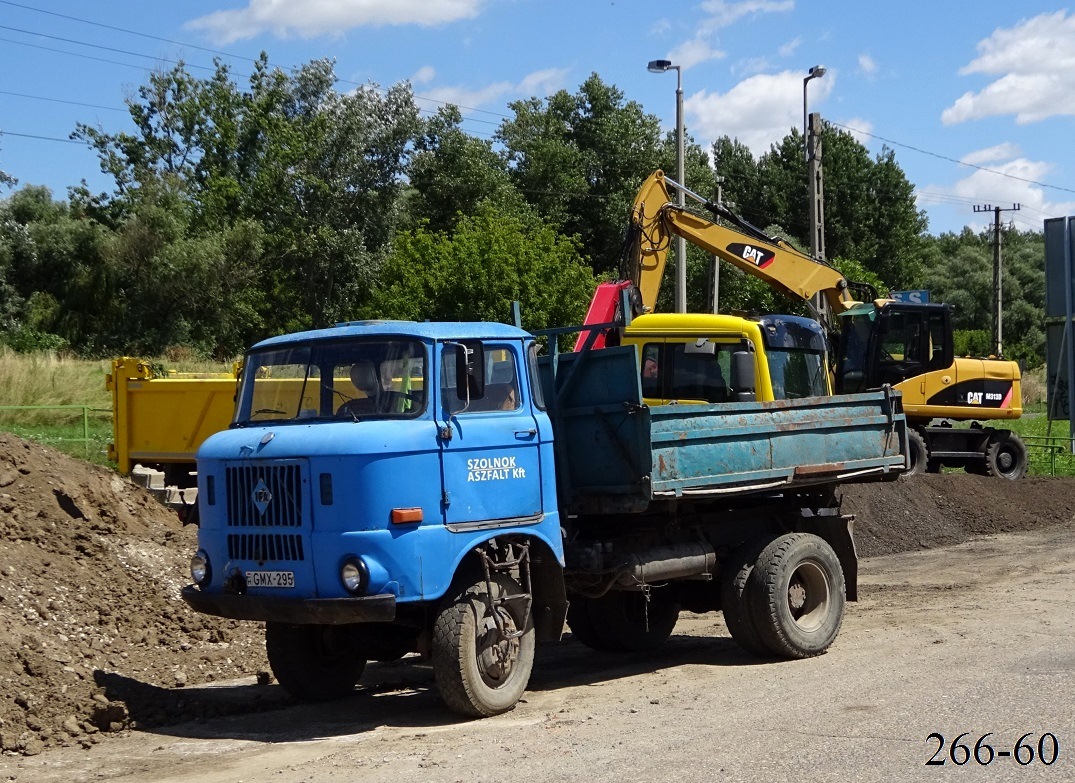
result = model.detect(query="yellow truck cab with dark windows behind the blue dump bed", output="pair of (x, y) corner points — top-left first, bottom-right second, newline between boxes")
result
(622, 313), (832, 405)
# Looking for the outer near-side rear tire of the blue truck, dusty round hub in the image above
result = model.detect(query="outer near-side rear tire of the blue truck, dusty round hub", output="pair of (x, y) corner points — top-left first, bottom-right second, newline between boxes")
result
(747, 532), (845, 658)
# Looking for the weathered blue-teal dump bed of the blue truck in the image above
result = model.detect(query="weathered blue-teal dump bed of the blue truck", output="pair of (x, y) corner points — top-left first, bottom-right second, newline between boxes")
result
(542, 346), (907, 513)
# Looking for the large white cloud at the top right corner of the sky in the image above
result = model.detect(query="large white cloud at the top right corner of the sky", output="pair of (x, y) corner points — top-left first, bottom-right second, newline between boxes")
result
(941, 11), (1075, 125)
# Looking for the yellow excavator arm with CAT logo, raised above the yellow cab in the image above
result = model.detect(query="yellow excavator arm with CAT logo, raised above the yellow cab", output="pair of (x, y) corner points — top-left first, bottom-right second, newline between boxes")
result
(624, 171), (859, 314)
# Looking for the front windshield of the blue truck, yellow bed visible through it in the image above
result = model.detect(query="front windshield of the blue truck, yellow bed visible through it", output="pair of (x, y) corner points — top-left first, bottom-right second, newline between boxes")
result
(232, 338), (427, 427)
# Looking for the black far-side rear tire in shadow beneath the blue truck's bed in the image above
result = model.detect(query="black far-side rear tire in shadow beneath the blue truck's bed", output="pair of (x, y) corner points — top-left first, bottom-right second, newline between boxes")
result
(568, 590), (679, 653)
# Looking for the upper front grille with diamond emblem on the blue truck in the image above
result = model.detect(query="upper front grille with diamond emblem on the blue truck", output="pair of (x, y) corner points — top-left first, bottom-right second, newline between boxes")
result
(225, 462), (302, 527)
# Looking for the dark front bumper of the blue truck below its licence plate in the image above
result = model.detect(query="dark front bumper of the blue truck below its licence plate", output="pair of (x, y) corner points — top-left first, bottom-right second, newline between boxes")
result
(180, 584), (396, 625)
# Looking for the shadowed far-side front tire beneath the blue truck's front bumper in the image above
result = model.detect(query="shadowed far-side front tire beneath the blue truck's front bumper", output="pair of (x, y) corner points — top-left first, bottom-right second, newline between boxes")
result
(266, 623), (366, 701)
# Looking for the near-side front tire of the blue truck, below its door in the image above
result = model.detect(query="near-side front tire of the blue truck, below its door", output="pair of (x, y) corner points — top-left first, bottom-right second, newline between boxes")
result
(432, 574), (534, 717)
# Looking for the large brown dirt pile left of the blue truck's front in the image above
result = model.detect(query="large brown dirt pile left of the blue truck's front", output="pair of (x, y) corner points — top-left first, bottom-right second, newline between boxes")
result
(0, 435), (267, 754)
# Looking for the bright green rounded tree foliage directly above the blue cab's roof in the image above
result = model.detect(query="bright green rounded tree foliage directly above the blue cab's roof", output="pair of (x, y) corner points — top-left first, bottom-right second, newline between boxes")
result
(360, 205), (597, 329)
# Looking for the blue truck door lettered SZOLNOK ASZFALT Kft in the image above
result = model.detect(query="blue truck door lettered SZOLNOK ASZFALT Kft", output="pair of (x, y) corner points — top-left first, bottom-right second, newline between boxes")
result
(438, 342), (542, 526)
